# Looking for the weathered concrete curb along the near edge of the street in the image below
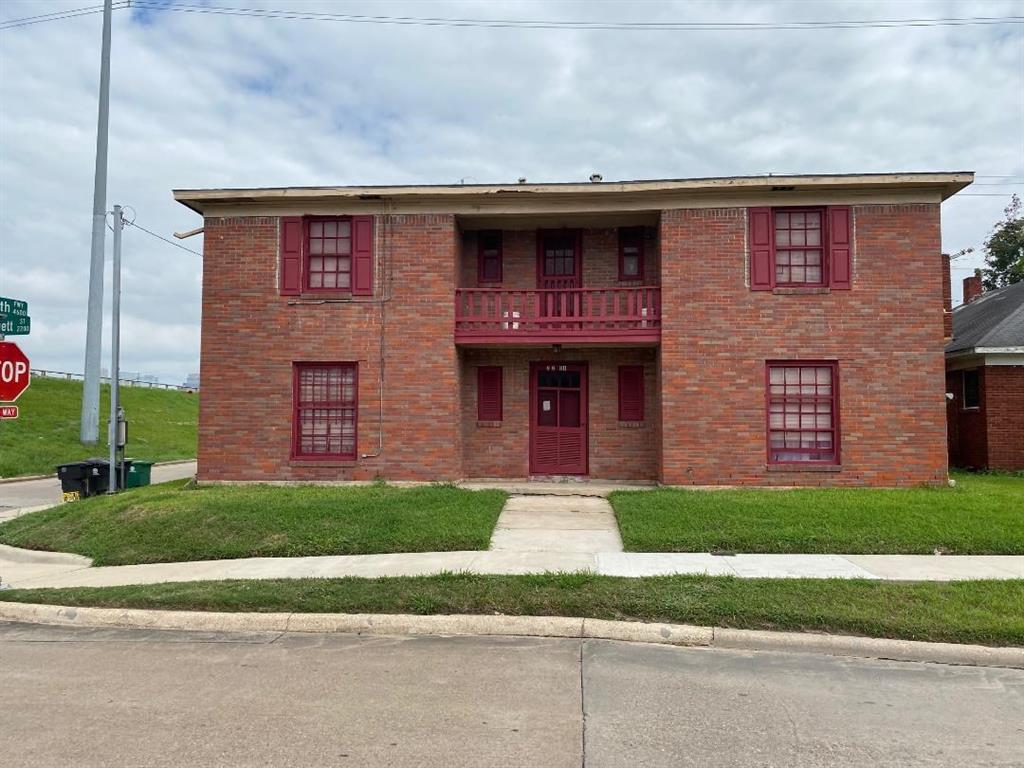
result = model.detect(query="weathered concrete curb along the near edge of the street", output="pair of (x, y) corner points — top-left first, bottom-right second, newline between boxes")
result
(0, 602), (1024, 670)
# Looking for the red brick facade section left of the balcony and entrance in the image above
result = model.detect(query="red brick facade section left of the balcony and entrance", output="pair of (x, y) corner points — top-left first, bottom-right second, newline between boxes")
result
(199, 215), (462, 480)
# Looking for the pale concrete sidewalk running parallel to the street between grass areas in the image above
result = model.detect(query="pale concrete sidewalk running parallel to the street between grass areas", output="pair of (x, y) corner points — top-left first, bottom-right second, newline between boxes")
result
(0, 546), (1024, 588)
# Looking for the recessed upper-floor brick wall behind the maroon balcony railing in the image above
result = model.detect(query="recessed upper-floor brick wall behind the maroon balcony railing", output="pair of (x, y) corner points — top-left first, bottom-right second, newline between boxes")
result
(459, 227), (660, 290)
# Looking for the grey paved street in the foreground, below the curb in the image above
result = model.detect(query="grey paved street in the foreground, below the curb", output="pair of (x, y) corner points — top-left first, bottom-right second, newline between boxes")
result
(0, 624), (1024, 768)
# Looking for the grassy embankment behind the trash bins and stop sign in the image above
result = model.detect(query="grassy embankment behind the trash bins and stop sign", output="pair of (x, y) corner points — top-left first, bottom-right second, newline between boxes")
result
(0, 377), (199, 477)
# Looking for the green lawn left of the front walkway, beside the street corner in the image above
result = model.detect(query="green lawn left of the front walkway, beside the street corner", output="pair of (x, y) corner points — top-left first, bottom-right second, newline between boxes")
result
(0, 480), (506, 565)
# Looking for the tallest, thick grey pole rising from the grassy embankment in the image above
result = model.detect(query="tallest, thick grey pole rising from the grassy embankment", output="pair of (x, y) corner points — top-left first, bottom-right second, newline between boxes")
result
(80, 0), (113, 444)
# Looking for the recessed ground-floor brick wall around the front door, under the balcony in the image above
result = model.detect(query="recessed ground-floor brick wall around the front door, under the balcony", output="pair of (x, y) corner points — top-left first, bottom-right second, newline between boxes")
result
(462, 348), (659, 480)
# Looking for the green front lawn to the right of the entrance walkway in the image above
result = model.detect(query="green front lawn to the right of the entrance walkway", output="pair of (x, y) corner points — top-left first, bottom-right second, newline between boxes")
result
(610, 473), (1024, 555)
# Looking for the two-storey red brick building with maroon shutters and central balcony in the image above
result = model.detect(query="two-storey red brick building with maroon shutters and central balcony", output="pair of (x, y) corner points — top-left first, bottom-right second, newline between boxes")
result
(175, 173), (973, 485)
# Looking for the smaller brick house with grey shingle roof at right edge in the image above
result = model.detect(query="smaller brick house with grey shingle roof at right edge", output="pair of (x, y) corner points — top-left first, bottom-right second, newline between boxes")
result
(946, 276), (1024, 470)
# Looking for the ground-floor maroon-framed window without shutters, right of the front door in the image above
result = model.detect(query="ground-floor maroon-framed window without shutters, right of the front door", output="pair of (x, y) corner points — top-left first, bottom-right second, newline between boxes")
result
(767, 361), (840, 464)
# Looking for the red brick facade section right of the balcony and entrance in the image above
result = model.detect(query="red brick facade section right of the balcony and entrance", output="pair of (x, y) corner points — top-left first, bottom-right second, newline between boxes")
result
(660, 204), (946, 485)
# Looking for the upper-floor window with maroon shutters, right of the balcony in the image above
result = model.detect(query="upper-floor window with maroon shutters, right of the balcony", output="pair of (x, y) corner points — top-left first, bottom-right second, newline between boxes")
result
(748, 206), (853, 291)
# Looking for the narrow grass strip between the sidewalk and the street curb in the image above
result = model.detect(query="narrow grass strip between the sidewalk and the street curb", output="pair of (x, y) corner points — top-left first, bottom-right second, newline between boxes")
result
(0, 573), (1024, 645)
